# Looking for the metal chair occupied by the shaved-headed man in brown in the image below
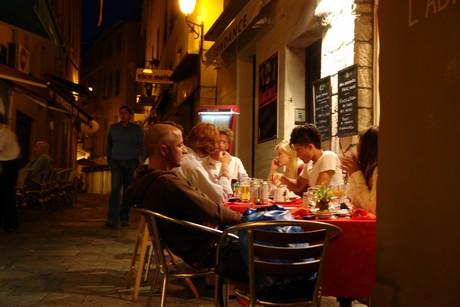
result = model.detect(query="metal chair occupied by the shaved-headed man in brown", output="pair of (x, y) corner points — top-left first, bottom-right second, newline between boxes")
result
(138, 208), (222, 307)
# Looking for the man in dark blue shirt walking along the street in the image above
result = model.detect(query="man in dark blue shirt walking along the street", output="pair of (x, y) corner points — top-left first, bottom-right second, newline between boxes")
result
(106, 106), (145, 227)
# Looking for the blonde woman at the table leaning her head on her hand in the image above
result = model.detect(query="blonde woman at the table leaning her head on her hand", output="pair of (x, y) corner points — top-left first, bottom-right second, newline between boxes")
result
(267, 140), (303, 194)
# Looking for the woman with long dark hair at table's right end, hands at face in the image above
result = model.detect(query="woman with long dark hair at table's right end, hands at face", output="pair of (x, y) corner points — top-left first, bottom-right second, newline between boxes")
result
(340, 126), (379, 214)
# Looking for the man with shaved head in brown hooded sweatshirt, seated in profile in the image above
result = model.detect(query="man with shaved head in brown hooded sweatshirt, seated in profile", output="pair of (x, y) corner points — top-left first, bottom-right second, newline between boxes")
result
(126, 124), (246, 280)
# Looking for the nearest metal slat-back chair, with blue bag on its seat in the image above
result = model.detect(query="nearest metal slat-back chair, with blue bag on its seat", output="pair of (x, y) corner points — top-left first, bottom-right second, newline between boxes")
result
(215, 220), (342, 306)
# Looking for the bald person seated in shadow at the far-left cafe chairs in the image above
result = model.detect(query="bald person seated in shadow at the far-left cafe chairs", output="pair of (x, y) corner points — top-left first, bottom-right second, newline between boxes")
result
(24, 141), (54, 190)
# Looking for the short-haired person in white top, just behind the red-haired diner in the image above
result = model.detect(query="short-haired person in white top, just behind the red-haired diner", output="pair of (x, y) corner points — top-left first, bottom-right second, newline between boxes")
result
(203, 127), (246, 181)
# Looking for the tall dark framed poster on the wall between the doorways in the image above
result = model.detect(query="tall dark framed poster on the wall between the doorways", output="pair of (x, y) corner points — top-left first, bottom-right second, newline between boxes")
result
(257, 53), (278, 143)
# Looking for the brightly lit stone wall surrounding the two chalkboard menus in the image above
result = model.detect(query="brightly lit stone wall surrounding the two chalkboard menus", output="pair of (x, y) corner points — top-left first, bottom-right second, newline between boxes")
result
(315, 0), (374, 153)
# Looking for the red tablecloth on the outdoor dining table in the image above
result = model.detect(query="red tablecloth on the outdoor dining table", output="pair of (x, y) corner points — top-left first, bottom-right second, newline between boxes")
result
(226, 199), (376, 297)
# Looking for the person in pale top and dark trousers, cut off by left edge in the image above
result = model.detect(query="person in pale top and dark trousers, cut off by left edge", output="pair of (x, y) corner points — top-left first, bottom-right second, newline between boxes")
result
(0, 114), (21, 232)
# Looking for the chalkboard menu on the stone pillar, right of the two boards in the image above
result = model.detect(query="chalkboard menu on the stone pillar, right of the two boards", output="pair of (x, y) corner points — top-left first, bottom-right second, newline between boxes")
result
(337, 65), (358, 136)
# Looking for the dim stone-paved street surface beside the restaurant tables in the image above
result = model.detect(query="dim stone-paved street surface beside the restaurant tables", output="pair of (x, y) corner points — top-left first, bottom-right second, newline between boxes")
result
(0, 194), (363, 307)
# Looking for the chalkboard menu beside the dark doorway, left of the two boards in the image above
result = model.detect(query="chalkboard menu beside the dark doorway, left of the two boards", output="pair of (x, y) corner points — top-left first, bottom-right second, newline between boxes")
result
(313, 77), (331, 140)
